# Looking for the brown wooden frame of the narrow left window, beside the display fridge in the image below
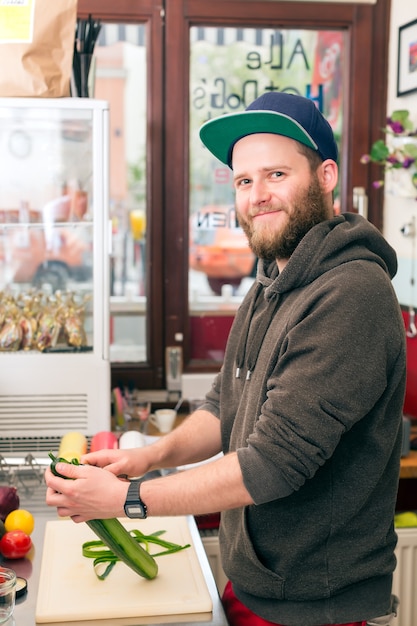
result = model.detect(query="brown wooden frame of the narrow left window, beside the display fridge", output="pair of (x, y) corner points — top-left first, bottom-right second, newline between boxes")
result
(77, 0), (165, 389)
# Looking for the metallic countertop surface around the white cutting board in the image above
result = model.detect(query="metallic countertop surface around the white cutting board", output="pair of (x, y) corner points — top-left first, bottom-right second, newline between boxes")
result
(3, 484), (228, 626)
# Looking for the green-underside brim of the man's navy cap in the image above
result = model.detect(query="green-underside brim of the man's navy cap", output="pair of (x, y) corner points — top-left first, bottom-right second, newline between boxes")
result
(200, 111), (318, 166)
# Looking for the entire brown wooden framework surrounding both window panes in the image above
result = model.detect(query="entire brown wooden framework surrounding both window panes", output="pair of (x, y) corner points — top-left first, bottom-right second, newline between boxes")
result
(78, 0), (391, 389)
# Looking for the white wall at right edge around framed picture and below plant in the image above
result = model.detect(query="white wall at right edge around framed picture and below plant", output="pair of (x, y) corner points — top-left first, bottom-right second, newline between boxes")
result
(383, 0), (417, 306)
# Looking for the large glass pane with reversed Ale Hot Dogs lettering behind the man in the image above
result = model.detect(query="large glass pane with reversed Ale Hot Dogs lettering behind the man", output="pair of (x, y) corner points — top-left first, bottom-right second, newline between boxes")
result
(189, 26), (344, 363)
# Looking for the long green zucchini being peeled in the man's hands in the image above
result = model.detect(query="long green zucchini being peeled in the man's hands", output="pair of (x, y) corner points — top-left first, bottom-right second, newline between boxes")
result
(49, 452), (158, 580)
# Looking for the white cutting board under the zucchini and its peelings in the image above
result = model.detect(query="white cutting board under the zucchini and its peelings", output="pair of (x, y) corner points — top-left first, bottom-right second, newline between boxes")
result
(36, 517), (213, 623)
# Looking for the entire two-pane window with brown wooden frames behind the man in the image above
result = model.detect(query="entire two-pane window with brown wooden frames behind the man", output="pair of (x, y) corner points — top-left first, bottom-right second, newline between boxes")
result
(71, 0), (389, 390)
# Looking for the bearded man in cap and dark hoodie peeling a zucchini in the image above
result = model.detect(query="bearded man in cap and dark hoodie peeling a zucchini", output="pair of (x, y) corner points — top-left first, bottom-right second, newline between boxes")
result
(46, 93), (406, 626)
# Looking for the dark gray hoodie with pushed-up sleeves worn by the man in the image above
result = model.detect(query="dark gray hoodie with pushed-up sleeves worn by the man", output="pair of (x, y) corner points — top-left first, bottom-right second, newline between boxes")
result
(205, 213), (406, 626)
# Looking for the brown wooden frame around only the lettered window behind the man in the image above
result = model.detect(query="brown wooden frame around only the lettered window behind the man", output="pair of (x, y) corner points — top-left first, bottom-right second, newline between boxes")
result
(164, 0), (390, 372)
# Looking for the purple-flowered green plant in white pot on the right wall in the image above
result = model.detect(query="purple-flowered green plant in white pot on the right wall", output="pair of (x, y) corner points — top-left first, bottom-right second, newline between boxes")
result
(361, 110), (417, 199)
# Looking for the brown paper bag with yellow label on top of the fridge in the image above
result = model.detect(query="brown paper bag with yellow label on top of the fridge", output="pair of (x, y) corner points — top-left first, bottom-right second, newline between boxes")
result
(0, 0), (77, 98)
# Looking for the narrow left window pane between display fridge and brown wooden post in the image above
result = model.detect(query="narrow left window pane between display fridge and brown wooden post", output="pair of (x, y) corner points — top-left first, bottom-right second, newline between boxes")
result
(94, 24), (147, 362)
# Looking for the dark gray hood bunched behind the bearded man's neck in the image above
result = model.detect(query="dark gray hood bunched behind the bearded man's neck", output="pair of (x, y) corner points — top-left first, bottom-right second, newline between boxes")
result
(256, 213), (397, 299)
